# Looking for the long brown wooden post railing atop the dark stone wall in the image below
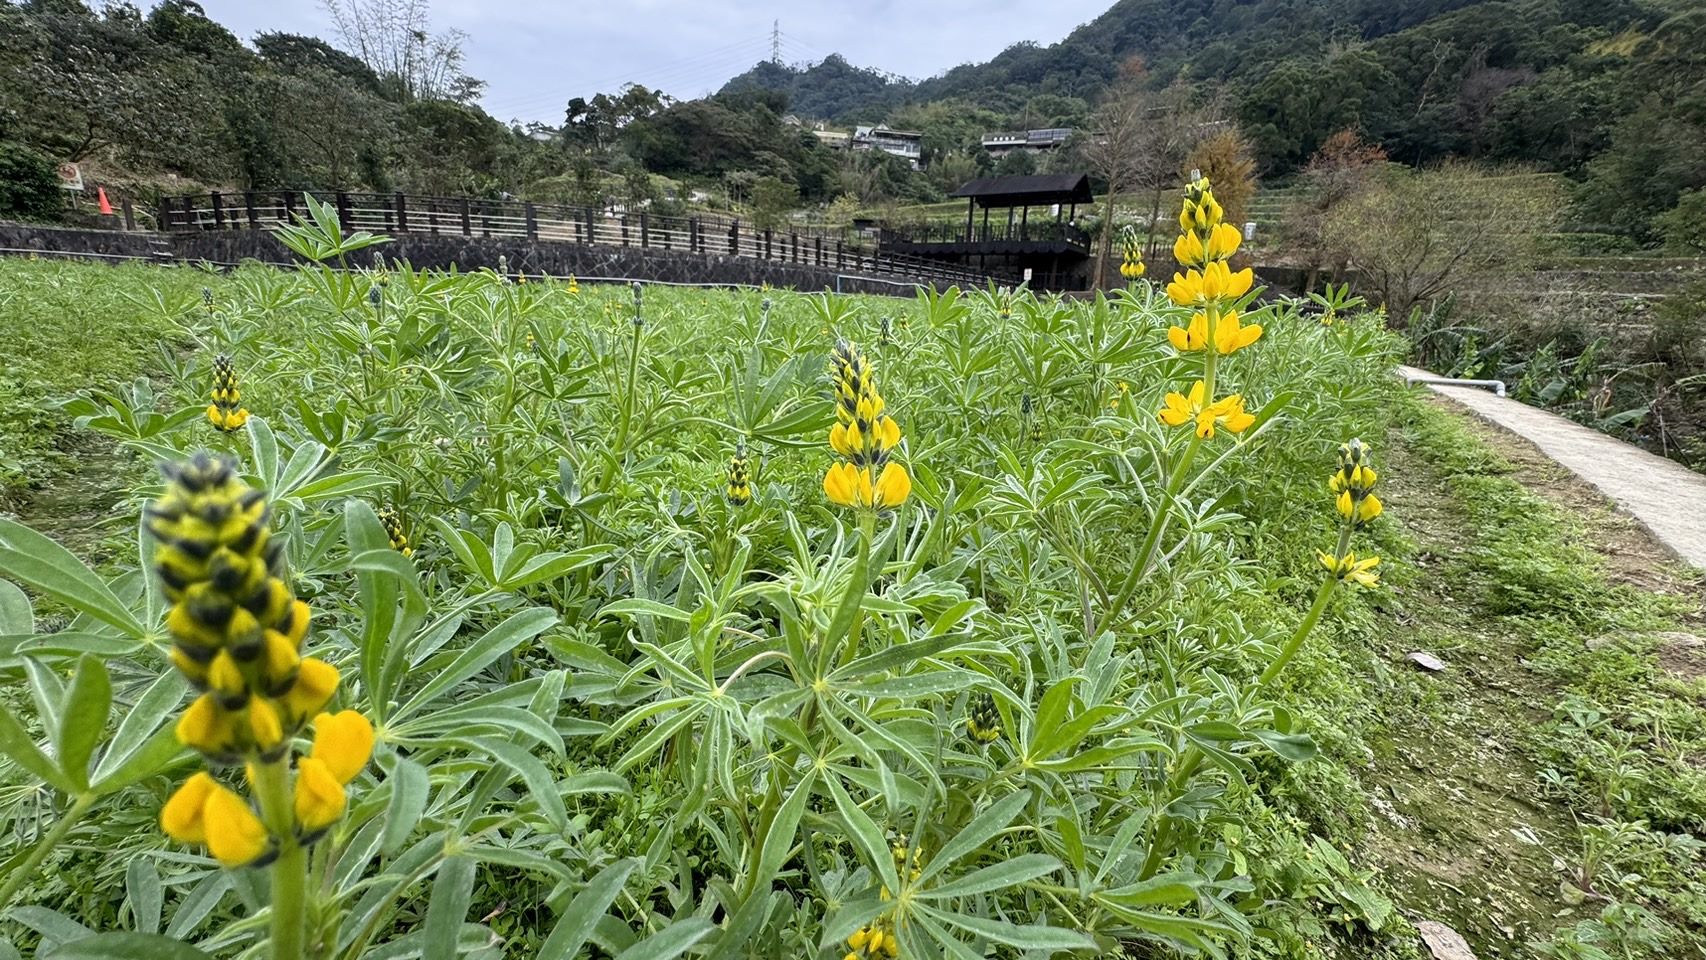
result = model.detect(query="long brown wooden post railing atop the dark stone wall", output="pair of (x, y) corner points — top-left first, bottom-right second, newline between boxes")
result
(159, 191), (1017, 286)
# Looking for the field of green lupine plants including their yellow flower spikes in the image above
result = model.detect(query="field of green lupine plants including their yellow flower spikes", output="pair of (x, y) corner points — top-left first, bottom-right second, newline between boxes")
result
(0, 181), (1426, 960)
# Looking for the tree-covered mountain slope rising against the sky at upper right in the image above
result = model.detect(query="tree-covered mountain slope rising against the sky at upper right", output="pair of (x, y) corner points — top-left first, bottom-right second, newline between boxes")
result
(725, 0), (1692, 172)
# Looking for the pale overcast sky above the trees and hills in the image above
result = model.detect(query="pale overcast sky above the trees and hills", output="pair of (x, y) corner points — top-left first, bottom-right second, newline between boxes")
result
(201, 0), (1112, 124)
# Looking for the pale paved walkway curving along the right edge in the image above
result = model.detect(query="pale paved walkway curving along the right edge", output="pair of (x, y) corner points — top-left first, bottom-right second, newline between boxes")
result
(1399, 367), (1706, 570)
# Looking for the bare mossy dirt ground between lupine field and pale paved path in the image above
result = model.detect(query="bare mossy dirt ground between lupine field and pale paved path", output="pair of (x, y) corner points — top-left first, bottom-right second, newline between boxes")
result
(1365, 397), (1703, 960)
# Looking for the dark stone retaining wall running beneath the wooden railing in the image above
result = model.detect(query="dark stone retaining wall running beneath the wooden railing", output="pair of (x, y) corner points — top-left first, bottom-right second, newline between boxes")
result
(171, 230), (962, 297)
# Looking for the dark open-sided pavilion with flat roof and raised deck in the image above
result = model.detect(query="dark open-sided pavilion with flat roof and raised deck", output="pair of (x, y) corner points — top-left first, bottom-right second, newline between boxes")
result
(877, 174), (1095, 290)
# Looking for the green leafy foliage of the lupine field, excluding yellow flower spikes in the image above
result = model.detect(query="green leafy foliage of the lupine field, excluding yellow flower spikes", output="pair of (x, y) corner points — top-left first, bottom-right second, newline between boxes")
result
(0, 250), (1426, 958)
